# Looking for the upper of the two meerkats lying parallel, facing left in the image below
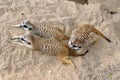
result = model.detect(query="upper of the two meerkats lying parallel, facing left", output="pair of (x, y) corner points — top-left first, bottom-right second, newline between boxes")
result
(12, 20), (69, 40)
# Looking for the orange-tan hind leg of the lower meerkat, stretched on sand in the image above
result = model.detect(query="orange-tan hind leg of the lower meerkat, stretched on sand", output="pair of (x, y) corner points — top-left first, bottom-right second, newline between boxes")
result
(57, 54), (75, 67)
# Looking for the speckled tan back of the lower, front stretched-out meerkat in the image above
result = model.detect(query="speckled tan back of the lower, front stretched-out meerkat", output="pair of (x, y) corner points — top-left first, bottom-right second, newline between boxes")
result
(33, 36), (68, 55)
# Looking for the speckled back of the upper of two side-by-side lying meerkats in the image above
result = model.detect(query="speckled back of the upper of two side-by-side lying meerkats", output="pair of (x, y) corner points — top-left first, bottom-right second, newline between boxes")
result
(32, 23), (69, 40)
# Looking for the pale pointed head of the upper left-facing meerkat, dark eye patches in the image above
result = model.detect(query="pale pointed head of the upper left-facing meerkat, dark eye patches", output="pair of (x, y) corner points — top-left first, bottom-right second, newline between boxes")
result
(12, 20), (34, 32)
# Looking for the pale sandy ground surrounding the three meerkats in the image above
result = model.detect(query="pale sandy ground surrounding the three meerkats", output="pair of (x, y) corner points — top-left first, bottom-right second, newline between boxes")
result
(0, 0), (120, 80)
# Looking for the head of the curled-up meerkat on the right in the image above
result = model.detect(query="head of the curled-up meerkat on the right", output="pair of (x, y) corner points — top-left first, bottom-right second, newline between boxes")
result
(68, 36), (82, 50)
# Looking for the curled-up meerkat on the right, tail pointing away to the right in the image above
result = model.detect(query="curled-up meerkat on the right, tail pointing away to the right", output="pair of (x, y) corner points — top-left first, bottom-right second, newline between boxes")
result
(68, 24), (111, 52)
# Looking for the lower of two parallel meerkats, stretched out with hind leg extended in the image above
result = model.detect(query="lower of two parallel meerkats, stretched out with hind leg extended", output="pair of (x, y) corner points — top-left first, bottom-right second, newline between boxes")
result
(10, 33), (86, 67)
